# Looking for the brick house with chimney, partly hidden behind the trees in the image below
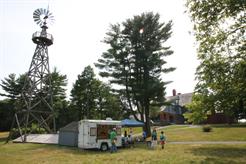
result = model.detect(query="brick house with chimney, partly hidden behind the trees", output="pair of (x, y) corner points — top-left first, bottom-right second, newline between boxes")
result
(158, 90), (192, 124)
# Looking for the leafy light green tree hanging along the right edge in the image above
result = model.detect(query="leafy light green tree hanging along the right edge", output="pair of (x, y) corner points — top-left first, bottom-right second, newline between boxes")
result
(186, 0), (246, 122)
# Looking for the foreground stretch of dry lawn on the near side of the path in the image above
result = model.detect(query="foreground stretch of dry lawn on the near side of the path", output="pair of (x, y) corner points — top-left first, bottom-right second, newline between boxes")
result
(0, 144), (246, 164)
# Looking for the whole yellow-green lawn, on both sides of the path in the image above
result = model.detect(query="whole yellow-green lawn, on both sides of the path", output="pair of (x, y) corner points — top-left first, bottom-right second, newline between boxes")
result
(0, 126), (246, 164)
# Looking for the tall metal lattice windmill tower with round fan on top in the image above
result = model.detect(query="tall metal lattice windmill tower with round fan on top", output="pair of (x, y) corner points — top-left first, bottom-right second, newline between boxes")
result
(10, 8), (56, 142)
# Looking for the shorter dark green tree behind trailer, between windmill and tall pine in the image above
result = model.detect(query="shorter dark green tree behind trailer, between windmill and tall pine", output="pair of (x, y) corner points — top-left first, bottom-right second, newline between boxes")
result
(71, 66), (120, 120)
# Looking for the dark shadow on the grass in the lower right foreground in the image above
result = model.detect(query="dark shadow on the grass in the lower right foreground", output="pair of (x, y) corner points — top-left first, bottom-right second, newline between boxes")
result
(192, 147), (246, 158)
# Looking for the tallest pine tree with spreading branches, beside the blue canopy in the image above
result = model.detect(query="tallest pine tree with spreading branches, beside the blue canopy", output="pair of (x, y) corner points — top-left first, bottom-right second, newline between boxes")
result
(95, 12), (174, 135)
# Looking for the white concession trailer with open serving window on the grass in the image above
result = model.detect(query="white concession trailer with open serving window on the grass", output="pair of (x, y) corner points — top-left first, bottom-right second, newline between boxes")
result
(78, 120), (122, 151)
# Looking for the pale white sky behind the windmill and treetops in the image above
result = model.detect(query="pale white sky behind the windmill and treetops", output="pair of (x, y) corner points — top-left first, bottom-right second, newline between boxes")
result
(0, 0), (198, 99)
